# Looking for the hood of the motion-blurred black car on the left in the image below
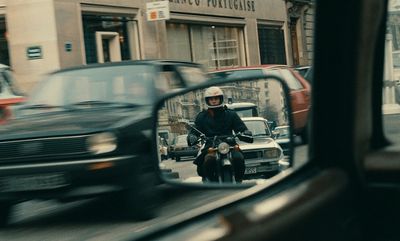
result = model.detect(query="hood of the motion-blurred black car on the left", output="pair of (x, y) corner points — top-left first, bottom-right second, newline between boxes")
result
(0, 107), (151, 140)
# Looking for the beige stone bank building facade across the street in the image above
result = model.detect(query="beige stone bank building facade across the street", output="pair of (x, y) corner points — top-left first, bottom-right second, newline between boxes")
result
(0, 0), (300, 91)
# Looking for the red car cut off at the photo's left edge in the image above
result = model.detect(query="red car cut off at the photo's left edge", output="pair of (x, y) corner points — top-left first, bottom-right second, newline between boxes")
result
(0, 64), (25, 124)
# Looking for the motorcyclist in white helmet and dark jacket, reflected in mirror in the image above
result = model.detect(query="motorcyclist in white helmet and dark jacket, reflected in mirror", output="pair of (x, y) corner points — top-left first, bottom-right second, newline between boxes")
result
(187, 86), (251, 182)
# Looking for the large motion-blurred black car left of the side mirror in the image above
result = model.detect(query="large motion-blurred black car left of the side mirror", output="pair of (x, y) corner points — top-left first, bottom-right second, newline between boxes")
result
(0, 60), (205, 225)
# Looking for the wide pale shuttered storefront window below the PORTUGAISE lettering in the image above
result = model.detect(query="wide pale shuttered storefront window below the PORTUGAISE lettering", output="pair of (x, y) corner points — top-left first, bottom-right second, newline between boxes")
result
(167, 23), (244, 70)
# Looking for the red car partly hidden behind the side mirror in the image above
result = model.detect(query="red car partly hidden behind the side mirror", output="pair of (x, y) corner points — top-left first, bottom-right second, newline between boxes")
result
(211, 65), (311, 143)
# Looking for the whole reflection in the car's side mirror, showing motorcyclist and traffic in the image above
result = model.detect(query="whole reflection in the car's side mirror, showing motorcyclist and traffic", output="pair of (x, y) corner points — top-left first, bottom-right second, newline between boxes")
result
(157, 79), (292, 184)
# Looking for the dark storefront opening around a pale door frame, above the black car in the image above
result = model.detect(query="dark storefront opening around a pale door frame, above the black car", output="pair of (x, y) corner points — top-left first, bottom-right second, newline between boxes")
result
(82, 14), (133, 64)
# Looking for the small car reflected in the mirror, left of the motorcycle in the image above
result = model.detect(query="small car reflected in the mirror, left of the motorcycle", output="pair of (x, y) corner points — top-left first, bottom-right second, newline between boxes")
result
(169, 134), (199, 162)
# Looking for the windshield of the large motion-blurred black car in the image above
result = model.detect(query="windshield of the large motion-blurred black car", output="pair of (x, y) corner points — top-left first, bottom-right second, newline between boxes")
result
(22, 65), (156, 110)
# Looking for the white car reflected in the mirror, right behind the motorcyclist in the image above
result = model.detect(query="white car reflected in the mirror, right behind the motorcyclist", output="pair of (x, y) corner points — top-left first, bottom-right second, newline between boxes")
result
(238, 117), (286, 179)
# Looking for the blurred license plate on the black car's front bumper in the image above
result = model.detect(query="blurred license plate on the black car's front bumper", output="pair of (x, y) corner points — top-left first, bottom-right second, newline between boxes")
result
(0, 173), (67, 192)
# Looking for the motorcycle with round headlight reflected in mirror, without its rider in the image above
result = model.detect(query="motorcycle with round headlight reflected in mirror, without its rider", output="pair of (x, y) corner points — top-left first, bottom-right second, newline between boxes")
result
(191, 126), (253, 183)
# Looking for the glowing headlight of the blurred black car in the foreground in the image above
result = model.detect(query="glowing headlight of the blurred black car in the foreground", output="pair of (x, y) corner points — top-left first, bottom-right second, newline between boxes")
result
(87, 132), (117, 154)
